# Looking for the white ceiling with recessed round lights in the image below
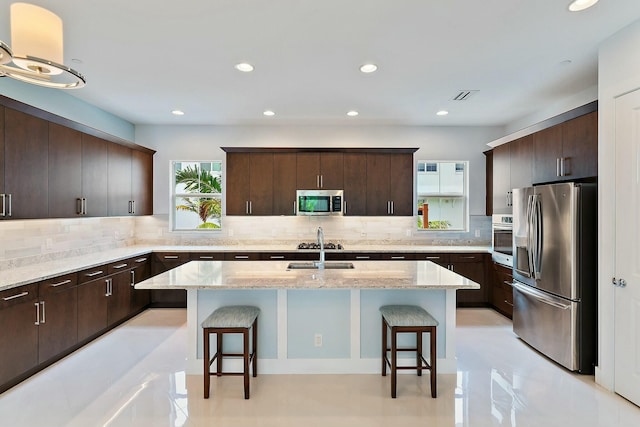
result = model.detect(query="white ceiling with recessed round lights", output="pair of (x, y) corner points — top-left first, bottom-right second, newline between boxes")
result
(0, 0), (640, 125)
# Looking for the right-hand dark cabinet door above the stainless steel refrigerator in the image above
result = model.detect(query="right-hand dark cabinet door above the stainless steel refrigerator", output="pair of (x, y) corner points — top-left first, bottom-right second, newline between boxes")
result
(562, 111), (598, 180)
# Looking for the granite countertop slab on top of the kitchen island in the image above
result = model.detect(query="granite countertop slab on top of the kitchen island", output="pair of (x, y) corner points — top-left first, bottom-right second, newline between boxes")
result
(136, 261), (480, 290)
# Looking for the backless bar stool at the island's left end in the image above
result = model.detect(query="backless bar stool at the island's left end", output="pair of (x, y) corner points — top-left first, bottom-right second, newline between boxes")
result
(202, 305), (260, 399)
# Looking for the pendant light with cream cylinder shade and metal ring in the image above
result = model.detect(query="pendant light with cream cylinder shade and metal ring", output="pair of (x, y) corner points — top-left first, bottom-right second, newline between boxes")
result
(0, 3), (86, 89)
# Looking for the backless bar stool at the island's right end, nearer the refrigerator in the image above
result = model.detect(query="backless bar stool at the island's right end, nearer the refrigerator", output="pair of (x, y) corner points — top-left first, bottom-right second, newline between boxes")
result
(380, 305), (438, 399)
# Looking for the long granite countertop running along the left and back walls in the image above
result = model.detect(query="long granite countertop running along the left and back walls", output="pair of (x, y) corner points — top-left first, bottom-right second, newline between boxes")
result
(0, 244), (491, 291)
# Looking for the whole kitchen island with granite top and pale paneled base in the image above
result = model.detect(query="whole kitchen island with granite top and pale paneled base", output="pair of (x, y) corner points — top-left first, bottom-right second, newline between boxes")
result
(136, 261), (479, 374)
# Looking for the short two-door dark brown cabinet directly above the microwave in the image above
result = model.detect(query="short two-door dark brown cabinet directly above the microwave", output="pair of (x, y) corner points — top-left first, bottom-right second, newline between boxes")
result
(296, 152), (344, 190)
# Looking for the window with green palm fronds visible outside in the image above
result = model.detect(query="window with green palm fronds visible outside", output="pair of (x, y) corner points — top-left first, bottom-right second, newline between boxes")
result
(171, 160), (222, 230)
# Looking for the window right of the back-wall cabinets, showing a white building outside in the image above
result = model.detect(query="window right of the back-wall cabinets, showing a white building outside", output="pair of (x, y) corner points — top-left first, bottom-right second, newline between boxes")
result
(416, 161), (469, 231)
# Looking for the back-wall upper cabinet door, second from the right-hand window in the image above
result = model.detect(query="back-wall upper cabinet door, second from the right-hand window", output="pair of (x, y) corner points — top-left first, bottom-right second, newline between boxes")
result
(367, 153), (391, 216)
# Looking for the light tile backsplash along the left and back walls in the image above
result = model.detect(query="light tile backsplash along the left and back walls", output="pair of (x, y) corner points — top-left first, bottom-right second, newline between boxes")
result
(0, 215), (491, 270)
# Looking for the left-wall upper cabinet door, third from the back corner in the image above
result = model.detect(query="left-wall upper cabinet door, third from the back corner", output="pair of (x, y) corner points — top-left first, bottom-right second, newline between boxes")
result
(82, 133), (108, 217)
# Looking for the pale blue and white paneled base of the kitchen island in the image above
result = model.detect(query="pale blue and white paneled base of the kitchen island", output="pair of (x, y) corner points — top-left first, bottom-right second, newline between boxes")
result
(182, 288), (456, 375)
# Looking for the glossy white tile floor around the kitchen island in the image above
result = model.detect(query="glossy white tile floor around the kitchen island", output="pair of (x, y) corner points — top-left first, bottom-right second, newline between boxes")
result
(0, 309), (640, 427)
